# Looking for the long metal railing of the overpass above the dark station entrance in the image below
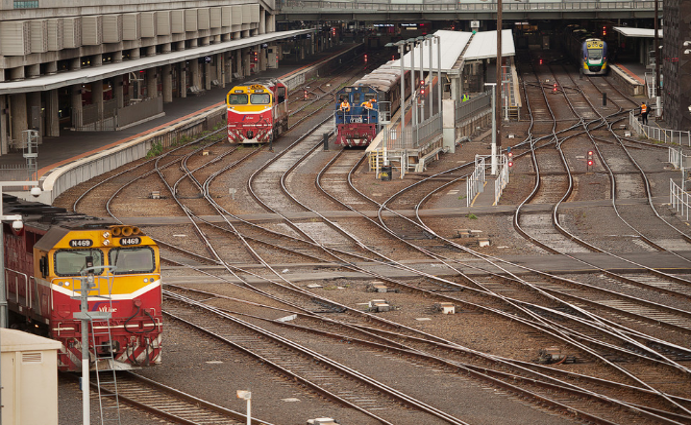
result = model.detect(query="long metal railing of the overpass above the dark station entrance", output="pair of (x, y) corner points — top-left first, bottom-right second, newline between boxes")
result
(279, 0), (662, 13)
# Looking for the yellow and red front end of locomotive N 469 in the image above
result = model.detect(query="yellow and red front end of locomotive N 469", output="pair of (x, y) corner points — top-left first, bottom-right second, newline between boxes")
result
(44, 225), (162, 370)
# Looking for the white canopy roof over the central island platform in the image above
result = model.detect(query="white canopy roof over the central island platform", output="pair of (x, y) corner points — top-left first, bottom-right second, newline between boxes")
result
(393, 30), (516, 73)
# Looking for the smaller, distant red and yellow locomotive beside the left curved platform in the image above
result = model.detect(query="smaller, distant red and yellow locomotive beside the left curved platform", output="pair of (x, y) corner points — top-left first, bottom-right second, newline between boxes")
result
(226, 79), (288, 144)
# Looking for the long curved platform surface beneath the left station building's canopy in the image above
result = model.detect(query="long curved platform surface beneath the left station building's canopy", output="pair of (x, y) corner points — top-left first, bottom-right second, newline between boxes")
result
(0, 44), (358, 180)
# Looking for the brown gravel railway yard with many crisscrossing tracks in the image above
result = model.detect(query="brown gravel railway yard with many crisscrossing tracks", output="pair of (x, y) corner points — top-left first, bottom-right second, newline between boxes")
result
(54, 53), (691, 425)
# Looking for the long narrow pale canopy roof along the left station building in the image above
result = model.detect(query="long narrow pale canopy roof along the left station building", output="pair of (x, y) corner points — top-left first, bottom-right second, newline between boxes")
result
(0, 29), (314, 95)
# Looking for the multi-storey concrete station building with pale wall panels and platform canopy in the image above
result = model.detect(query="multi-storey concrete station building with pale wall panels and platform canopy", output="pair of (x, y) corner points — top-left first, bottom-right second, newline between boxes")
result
(0, 0), (315, 155)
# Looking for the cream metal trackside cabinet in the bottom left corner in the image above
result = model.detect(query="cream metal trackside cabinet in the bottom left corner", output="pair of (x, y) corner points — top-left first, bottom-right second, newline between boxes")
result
(0, 329), (62, 425)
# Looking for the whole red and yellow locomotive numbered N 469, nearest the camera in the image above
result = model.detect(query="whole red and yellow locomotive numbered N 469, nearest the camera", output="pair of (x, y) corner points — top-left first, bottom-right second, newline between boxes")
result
(2, 195), (163, 371)
